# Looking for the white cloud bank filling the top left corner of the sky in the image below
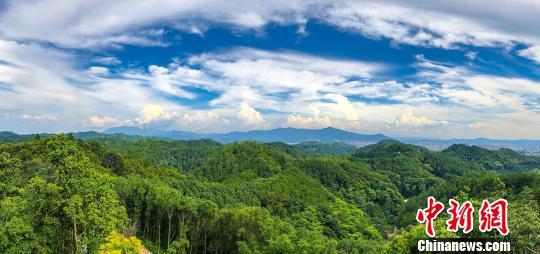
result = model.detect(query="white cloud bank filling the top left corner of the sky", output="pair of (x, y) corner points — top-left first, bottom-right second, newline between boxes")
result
(0, 0), (309, 48)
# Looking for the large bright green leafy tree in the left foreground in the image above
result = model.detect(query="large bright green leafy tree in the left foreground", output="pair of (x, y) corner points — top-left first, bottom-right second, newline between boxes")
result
(0, 135), (127, 253)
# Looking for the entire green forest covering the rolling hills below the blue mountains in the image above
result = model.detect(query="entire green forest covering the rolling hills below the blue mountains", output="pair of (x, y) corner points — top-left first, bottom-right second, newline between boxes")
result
(0, 135), (540, 253)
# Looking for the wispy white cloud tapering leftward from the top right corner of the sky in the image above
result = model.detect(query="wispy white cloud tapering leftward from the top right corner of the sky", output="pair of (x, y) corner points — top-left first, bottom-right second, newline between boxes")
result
(316, 0), (540, 63)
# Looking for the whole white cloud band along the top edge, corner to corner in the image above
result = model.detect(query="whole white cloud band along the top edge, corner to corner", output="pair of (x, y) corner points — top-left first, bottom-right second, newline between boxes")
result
(0, 0), (540, 64)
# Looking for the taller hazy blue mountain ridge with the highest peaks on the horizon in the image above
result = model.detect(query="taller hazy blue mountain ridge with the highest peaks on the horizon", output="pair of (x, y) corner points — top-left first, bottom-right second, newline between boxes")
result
(103, 127), (391, 145)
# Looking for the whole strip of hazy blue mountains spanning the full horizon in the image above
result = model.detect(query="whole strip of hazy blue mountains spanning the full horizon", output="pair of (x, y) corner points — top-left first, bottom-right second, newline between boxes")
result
(4, 126), (540, 155)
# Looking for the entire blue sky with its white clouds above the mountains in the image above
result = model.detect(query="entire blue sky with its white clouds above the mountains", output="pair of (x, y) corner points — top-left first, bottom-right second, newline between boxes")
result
(0, 0), (540, 139)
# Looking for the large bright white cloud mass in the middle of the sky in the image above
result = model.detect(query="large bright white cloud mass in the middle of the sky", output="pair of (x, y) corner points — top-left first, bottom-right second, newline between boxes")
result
(100, 48), (384, 125)
